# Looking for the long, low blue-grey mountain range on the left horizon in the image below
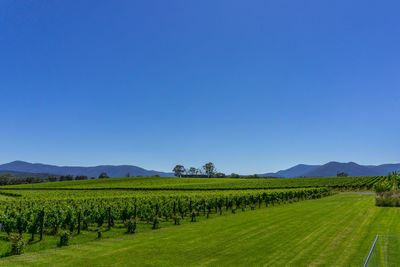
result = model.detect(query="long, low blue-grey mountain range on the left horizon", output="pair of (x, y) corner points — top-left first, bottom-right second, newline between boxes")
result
(0, 161), (173, 178)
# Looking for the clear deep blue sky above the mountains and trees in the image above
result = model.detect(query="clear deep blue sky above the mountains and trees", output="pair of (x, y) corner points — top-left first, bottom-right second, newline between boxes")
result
(0, 0), (400, 174)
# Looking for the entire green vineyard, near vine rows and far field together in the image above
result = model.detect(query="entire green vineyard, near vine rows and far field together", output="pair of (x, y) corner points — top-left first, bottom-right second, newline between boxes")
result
(0, 176), (385, 264)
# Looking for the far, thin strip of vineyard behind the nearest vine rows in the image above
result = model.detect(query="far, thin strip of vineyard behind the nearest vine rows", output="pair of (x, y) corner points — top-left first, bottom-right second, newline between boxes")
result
(1, 176), (384, 190)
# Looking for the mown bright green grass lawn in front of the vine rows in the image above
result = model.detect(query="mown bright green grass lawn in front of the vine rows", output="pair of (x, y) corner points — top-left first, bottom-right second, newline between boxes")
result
(0, 194), (400, 266)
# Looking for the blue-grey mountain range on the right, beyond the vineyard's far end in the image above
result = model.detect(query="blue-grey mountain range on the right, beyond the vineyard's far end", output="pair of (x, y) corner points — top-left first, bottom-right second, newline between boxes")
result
(260, 161), (400, 178)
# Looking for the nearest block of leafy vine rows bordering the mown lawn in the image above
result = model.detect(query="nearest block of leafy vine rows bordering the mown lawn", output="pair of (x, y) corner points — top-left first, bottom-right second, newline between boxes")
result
(0, 188), (331, 240)
